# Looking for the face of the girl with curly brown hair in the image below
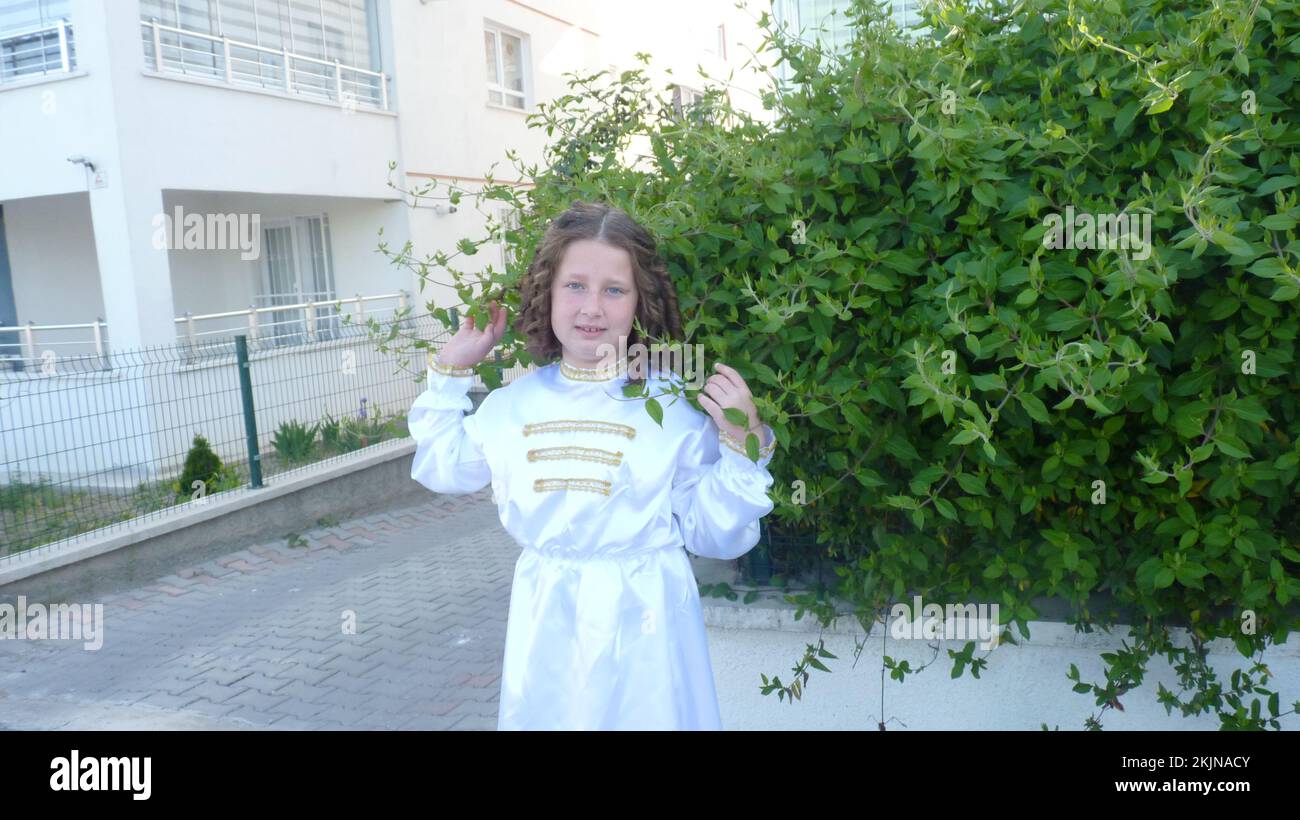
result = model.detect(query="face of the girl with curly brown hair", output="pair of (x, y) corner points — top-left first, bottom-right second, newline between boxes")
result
(551, 239), (637, 368)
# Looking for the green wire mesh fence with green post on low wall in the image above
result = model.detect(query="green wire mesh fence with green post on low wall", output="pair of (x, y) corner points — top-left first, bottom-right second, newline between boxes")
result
(0, 314), (525, 560)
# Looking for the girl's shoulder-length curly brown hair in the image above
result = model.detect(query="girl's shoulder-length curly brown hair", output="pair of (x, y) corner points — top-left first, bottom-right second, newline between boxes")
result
(515, 200), (685, 383)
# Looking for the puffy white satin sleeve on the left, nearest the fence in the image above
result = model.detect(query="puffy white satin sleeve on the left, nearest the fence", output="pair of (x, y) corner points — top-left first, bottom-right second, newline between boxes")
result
(407, 366), (491, 495)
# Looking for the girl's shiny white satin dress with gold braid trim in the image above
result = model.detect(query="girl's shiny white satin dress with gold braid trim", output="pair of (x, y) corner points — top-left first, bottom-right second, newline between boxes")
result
(407, 363), (776, 729)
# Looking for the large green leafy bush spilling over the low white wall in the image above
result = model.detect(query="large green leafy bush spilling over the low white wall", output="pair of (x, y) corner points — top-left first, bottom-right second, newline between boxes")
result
(381, 0), (1300, 728)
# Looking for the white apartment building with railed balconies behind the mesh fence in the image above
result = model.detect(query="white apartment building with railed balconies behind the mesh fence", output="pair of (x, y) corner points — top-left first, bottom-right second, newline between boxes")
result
(0, 0), (771, 372)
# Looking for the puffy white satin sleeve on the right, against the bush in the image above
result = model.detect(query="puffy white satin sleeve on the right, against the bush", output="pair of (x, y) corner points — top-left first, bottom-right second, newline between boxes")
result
(671, 416), (776, 559)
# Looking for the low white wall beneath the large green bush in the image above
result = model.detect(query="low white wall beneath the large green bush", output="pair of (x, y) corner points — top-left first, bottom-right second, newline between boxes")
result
(705, 610), (1300, 732)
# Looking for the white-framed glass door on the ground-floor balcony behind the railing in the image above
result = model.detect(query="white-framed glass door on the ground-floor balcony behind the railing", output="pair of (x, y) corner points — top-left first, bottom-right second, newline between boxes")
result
(256, 214), (341, 346)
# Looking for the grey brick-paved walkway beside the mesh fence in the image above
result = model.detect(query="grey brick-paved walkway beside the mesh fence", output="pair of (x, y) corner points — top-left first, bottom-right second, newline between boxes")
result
(0, 490), (519, 729)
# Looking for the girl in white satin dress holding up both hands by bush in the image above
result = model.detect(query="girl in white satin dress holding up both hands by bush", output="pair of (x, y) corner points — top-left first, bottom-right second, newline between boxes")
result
(408, 203), (776, 729)
